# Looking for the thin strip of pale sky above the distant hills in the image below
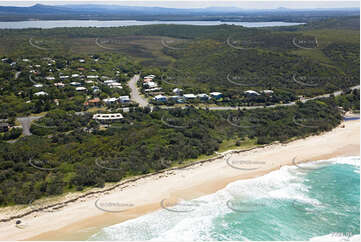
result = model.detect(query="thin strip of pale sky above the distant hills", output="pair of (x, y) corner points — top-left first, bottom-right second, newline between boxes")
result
(0, 0), (360, 9)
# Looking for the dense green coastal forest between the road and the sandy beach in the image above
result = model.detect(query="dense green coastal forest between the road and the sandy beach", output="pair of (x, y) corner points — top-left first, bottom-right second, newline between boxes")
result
(0, 90), (360, 205)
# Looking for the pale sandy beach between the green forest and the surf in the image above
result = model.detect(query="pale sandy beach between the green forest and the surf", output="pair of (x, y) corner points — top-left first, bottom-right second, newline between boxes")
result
(0, 120), (360, 240)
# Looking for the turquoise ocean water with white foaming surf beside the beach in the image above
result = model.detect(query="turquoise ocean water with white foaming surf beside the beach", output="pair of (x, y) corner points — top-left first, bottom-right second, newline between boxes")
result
(90, 157), (360, 241)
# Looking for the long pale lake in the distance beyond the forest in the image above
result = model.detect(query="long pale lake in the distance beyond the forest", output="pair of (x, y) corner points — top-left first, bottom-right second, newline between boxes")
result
(0, 20), (304, 29)
